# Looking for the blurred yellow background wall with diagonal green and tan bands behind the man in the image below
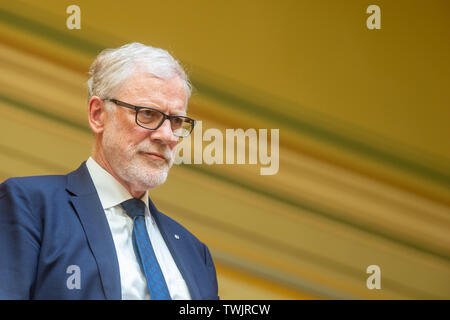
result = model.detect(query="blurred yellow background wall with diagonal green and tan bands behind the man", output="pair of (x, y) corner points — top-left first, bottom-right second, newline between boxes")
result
(0, 0), (450, 299)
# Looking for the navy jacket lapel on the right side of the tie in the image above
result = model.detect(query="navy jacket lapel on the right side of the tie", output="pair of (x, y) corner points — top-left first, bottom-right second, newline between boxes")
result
(149, 198), (201, 300)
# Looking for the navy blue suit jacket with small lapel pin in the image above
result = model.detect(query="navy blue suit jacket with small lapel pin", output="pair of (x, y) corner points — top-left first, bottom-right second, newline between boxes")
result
(0, 163), (218, 299)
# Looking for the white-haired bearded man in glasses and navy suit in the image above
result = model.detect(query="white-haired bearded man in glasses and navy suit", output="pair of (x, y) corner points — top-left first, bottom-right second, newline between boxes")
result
(0, 43), (218, 299)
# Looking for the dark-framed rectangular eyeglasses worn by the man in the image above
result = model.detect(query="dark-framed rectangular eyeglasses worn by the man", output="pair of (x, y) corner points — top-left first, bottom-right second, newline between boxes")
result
(103, 99), (195, 138)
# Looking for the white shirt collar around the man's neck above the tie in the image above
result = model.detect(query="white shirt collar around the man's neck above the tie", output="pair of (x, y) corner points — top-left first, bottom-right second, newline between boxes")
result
(86, 157), (148, 211)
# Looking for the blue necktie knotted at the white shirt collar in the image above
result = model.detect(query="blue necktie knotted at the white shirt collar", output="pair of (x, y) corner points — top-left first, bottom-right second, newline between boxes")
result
(122, 198), (171, 300)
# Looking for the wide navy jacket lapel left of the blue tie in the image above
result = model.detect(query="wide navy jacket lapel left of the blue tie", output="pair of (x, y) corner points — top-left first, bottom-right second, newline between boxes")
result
(67, 163), (121, 300)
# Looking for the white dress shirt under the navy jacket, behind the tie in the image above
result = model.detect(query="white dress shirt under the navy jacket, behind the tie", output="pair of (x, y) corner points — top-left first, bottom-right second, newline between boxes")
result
(86, 157), (191, 300)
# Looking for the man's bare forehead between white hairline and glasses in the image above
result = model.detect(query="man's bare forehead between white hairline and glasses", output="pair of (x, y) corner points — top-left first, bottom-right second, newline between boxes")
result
(118, 72), (187, 110)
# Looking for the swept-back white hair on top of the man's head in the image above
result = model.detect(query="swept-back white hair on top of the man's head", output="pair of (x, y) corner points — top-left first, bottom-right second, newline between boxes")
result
(87, 42), (192, 105)
